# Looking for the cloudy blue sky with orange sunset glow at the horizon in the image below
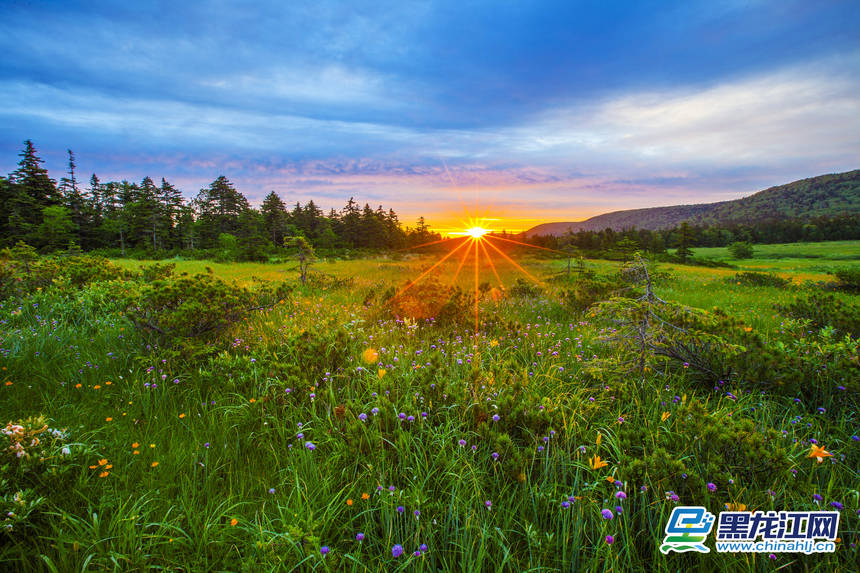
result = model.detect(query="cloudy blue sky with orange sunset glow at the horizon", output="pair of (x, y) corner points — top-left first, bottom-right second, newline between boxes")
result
(0, 0), (860, 232)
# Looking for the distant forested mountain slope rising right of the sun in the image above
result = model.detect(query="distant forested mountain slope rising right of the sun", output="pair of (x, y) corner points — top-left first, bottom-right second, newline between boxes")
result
(524, 169), (860, 237)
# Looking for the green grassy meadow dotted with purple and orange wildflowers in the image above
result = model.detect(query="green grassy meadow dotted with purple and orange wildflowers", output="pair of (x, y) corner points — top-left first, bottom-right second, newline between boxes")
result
(0, 242), (860, 571)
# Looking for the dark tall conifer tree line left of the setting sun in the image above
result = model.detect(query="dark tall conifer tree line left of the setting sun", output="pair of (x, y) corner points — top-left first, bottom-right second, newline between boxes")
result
(0, 140), (441, 260)
